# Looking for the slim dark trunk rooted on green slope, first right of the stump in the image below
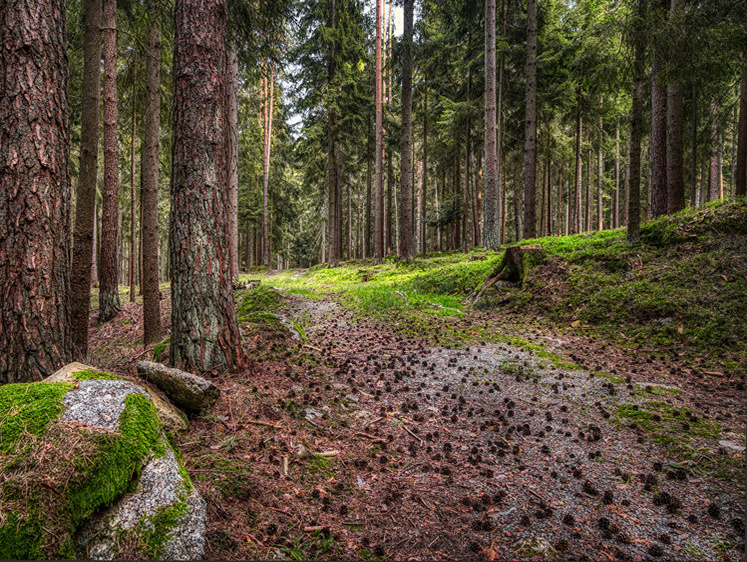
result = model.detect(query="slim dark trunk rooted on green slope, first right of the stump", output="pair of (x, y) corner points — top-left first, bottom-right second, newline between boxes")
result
(628, 0), (647, 243)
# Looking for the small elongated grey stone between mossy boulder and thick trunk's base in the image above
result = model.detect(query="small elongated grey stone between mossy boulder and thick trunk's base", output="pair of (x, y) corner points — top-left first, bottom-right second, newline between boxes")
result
(137, 361), (220, 412)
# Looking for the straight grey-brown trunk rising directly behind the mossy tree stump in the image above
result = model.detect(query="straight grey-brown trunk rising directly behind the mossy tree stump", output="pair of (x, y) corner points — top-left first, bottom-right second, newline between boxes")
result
(524, 0), (537, 238)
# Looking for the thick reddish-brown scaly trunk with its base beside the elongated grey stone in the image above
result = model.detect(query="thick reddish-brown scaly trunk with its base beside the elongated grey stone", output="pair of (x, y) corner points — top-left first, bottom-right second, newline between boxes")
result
(169, 0), (244, 371)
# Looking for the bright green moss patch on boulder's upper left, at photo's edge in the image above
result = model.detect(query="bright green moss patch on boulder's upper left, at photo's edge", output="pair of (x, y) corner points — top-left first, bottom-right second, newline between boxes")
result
(0, 383), (73, 458)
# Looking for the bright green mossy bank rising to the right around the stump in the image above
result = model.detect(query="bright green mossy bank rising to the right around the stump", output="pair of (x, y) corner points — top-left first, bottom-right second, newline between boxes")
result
(250, 198), (747, 373)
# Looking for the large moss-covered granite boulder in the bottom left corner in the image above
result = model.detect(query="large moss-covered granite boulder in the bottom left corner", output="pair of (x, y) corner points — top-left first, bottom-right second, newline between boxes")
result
(0, 370), (205, 560)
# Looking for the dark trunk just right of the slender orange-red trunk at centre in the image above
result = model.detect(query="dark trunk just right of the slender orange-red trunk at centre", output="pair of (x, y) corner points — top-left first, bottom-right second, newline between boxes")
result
(399, 0), (415, 260)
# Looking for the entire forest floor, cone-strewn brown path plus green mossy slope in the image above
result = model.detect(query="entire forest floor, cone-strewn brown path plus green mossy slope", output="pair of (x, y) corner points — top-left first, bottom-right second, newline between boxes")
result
(89, 199), (747, 562)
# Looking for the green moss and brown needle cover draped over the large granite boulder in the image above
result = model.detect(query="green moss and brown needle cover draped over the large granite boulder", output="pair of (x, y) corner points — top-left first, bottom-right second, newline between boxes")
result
(0, 384), (165, 559)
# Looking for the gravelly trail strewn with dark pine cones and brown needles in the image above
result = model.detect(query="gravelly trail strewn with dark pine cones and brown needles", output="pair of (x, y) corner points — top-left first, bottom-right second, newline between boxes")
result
(276, 290), (744, 560)
